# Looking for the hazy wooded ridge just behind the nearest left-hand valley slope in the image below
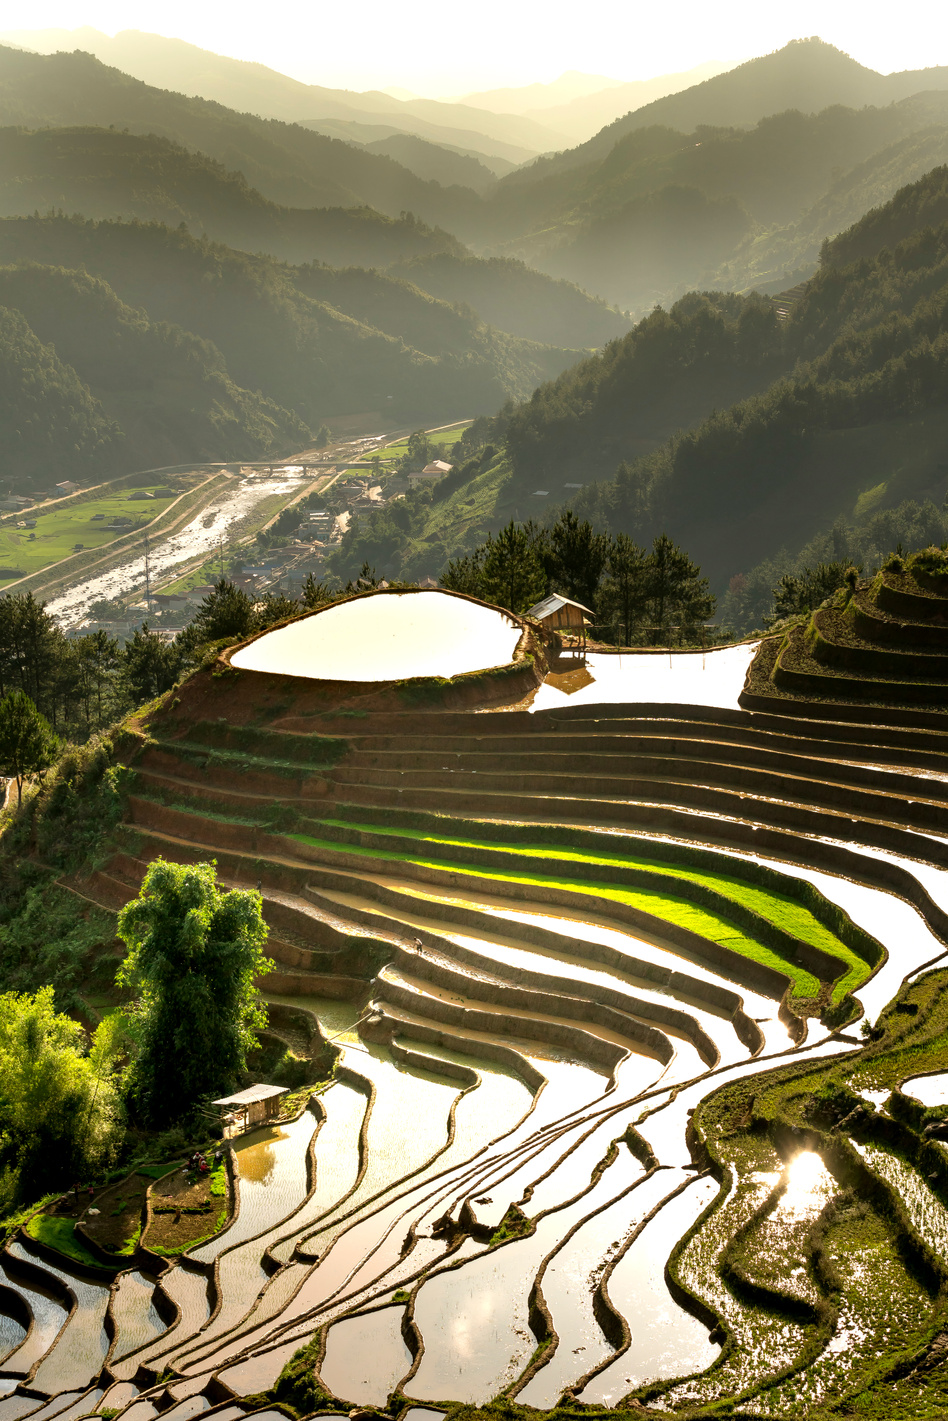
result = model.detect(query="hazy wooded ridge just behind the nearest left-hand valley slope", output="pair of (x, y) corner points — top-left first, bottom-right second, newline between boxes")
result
(0, 217), (576, 428)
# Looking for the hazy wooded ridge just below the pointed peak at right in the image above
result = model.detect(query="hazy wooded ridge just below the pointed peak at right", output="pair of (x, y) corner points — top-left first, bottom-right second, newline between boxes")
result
(490, 92), (948, 311)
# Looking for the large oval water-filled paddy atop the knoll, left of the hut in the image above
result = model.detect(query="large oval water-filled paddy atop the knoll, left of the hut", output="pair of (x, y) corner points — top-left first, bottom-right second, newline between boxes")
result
(232, 591), (520, 681)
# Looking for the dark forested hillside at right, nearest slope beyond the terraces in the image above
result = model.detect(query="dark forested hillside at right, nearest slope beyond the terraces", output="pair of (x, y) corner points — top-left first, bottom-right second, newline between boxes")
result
(395, 169), (948, 591)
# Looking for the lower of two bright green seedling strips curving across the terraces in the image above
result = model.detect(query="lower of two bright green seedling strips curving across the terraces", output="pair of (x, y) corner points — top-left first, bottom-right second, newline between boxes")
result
(286, 831), (830, 998)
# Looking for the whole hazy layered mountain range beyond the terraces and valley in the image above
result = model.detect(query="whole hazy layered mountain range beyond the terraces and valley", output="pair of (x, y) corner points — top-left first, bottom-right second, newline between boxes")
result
(0, 34), (948, 599)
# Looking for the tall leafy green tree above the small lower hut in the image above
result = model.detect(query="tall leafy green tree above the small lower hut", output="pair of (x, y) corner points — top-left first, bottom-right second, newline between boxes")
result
(118, 858), (273, 1124)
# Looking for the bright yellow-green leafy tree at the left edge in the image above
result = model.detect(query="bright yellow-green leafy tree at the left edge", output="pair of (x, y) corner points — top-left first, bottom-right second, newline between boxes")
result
(0, 986), (124, 1205)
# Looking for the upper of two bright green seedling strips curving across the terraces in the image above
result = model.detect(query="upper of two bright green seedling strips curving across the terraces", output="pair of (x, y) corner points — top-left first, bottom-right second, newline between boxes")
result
(308, 820), (870, 1002)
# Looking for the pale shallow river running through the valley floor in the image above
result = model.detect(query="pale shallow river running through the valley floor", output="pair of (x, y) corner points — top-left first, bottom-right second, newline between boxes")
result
(47, 465), (304, 627)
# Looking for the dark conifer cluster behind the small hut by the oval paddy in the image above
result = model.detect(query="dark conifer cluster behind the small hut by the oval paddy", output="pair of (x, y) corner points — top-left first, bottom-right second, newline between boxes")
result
(441, 509), (715, 647)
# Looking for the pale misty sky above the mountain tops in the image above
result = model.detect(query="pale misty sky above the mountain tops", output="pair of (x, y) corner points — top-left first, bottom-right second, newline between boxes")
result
(3, 0), (948, 97)
